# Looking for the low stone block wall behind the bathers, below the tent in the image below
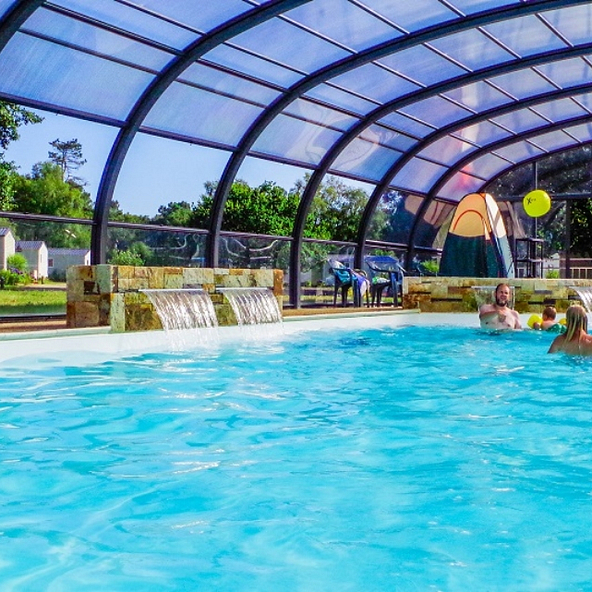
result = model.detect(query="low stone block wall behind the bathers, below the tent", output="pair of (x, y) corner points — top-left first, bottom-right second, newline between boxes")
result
(403, 276), (592, 314)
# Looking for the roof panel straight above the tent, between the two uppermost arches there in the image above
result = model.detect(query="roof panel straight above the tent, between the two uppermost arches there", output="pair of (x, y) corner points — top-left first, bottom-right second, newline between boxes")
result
(431, 29), (514, 70)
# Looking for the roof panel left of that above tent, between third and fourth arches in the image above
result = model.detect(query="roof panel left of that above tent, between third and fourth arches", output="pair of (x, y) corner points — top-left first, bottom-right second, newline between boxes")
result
(378, 45), (466, 85)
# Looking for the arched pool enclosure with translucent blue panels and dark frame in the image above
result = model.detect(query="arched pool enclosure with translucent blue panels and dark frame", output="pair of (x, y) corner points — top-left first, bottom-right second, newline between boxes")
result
(0, 0), (592, 307)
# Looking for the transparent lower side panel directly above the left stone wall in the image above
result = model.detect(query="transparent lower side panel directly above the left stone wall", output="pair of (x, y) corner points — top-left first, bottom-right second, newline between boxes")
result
(107, 226), (206, 267)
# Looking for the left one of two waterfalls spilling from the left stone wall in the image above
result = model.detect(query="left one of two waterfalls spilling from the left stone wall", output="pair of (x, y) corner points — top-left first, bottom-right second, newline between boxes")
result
(141, 288), (218, 331)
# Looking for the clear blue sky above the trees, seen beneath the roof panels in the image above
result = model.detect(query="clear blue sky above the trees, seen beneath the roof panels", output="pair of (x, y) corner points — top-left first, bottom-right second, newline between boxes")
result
(5, 111), (305, 216)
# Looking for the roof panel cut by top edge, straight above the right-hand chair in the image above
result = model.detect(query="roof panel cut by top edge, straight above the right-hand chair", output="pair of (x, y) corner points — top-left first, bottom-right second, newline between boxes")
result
(364, 0), (457, 31)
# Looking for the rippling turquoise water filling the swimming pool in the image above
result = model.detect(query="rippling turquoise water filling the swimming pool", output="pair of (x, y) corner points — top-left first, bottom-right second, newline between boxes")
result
(0, 327), (592, 592)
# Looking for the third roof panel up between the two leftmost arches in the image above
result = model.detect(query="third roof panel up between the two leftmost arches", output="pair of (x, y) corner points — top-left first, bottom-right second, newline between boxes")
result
(50, 0), (196, 49)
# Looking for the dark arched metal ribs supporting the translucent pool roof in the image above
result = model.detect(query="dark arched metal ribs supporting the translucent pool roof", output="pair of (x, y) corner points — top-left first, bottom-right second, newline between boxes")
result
(0, 0), (592, 306)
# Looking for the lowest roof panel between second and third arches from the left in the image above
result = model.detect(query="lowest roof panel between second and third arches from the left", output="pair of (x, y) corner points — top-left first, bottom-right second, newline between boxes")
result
(145, 83), (261, 146)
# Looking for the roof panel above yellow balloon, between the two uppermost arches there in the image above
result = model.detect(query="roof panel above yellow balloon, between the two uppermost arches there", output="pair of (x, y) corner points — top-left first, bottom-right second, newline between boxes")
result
(485, 15), (565, 56)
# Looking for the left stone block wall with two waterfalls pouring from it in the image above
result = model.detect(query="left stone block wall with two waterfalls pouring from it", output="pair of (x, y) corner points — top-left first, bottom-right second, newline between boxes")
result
(67, 265), (283, 333)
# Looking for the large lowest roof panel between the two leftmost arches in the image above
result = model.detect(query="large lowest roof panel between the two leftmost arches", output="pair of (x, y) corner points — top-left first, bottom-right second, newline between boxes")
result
(0, 34), (153, 120)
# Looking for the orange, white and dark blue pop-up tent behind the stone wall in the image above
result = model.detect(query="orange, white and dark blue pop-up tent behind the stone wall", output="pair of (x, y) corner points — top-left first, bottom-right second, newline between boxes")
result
(440, 193), (514, 277)
